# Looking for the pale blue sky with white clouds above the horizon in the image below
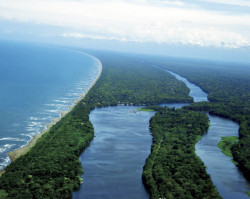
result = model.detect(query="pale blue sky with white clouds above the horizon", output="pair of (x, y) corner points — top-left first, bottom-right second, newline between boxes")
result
(0, 0), (250, 62)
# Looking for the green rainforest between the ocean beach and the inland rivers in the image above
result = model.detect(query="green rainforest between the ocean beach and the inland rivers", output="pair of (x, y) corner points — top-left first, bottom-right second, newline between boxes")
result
(0, 53), (192, 199)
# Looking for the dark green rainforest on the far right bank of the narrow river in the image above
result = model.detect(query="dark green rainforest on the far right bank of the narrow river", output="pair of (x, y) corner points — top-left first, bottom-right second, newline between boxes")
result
(148, 55), (250, 180)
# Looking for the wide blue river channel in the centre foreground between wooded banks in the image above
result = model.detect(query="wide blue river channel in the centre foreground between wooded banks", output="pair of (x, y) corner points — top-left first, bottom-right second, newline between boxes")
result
(73, 106), (155, 199)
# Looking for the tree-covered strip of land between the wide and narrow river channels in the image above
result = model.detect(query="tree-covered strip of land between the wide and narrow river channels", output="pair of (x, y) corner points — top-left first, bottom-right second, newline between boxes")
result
(143, 108), (221, 199)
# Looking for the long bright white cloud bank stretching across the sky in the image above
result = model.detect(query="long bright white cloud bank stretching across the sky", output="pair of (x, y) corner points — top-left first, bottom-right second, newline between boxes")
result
(0, 0), (250, 48)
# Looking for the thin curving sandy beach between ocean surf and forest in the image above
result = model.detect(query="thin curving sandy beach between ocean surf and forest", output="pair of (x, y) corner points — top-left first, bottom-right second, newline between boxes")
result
(0, 52), (102, 177)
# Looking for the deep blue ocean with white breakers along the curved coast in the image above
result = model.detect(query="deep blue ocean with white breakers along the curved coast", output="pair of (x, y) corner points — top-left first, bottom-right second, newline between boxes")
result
(0, 41), (100, 169)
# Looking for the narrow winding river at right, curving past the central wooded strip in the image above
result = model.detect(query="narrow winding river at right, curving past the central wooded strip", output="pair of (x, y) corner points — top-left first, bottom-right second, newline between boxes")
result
(167, 71), (250, 199)
